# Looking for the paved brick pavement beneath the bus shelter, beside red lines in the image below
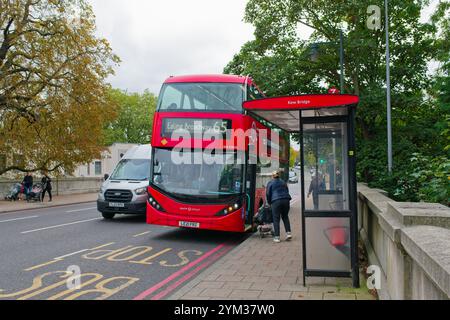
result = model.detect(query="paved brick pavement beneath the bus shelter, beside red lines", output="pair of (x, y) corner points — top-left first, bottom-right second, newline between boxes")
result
(168, 196), (376, 300)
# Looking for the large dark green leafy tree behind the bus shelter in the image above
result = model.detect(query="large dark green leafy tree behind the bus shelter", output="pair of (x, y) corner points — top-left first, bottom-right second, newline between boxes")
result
(224, 0), (450, 205)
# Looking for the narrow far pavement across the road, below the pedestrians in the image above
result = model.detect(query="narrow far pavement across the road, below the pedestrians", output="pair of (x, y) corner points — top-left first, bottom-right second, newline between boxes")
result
(0, 193), (97, 214)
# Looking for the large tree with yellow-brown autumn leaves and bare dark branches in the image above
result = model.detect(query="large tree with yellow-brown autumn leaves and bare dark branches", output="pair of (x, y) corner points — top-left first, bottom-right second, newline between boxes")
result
(0, 0), (119, 174)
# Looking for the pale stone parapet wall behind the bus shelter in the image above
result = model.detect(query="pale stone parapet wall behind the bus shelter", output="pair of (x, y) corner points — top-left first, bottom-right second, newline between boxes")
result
(358, 184), (450, 300)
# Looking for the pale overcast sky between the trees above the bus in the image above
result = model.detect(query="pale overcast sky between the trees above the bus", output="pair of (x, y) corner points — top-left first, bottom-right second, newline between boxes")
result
(89, 0), (437, 94)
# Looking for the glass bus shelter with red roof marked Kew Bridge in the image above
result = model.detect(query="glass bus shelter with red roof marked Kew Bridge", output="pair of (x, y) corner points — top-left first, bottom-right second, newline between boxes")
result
(244, 94), (359, 287)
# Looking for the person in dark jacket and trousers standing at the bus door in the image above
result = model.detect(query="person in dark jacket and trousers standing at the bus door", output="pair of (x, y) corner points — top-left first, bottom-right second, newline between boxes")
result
(266, 171), (292, 243)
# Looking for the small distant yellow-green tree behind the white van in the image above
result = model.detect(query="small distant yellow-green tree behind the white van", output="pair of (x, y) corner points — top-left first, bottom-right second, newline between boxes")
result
(105, 89), (157, 145)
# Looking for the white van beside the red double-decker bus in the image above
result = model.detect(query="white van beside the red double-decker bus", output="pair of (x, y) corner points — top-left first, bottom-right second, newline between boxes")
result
(97, 145), (152, 219)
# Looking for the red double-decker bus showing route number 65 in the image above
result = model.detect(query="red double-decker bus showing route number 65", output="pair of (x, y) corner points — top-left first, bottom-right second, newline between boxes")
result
(147, 75), (289, 232)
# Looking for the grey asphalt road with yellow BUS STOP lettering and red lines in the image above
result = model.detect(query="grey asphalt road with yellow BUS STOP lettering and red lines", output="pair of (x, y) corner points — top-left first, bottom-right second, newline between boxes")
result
(0, 203), (248, 300)
